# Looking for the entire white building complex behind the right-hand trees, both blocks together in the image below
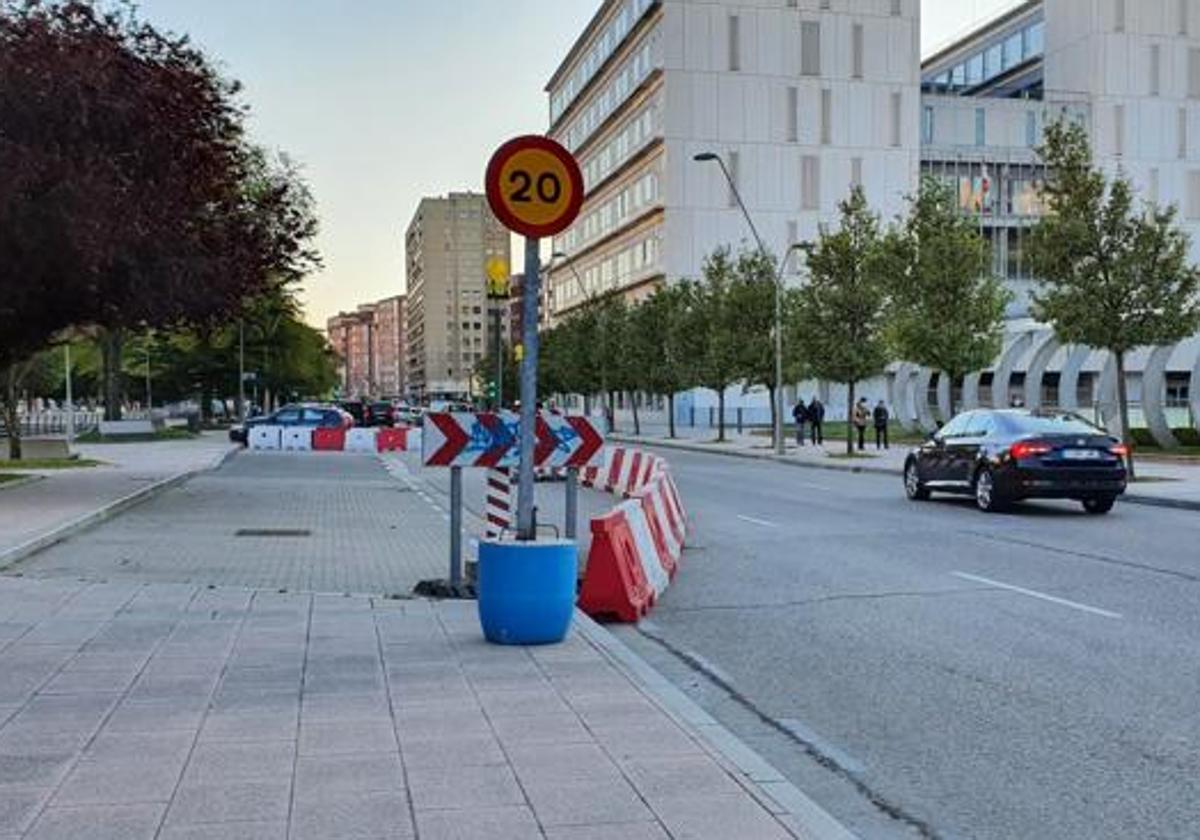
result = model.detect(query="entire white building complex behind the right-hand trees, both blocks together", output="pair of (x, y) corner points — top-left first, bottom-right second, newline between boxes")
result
(547, 0), (1200, 444)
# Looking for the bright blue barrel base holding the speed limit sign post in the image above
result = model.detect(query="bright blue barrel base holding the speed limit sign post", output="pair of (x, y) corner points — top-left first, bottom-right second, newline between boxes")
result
(476, 540), (578, 644)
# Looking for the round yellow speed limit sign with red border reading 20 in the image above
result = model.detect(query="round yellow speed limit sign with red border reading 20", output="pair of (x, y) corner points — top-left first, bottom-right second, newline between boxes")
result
(486, 134), (583, 239)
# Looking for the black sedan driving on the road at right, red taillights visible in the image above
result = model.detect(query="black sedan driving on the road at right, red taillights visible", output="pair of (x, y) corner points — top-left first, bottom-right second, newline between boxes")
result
(904, 409), (1126, 514)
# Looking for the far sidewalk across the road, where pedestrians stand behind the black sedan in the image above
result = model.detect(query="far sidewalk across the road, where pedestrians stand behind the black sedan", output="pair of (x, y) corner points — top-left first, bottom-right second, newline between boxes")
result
(608, 427), (1200, 510)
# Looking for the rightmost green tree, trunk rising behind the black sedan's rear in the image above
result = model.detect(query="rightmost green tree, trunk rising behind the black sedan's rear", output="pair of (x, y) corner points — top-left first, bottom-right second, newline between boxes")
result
(1027, 121), (1200, 478)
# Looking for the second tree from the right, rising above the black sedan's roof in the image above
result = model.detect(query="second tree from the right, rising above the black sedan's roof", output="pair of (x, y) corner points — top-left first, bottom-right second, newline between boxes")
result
(886, 178), (1009, 415)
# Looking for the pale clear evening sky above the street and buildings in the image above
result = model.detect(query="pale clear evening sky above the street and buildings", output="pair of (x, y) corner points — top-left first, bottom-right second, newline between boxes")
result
(139, 0), (1018, 326)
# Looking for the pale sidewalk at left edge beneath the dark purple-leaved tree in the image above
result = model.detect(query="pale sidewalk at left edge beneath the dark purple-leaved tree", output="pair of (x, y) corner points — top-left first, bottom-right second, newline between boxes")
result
(0, 433), (233, 556)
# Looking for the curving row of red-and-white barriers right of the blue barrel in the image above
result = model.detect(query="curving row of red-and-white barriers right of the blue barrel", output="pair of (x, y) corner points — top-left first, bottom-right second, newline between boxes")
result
(578, 446), (688, 622)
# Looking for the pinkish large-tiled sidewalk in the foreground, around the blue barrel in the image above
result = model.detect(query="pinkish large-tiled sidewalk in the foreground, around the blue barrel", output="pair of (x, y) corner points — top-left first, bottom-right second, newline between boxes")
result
(0, 578), (811, 840)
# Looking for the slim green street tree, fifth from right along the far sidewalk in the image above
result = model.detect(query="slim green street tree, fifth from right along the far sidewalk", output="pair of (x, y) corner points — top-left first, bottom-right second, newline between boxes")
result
(685, 247), (745, 443)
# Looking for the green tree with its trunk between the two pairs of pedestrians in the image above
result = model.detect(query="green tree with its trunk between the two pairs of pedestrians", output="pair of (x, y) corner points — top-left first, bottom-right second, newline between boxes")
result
(796, 186), (888, 455)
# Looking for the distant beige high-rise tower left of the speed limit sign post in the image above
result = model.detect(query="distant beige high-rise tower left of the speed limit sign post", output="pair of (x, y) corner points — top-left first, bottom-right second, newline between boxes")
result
(404, 192), (511, 398)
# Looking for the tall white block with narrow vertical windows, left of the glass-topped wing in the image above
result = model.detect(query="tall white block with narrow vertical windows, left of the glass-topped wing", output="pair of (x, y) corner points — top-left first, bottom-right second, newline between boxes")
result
(546, 0), (920, 318)
